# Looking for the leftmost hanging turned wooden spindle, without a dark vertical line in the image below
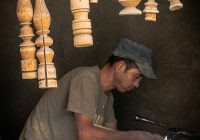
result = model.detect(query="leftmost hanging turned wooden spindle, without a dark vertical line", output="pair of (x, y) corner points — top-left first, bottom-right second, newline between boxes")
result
(16, 0), (37, 79)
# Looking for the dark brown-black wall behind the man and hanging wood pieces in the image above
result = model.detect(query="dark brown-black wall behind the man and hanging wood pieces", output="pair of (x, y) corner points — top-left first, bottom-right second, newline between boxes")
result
(0, 0), (200, 140)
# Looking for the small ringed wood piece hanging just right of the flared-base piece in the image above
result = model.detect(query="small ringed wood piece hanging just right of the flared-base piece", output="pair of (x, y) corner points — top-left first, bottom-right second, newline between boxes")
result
(143, 0), (159, 21)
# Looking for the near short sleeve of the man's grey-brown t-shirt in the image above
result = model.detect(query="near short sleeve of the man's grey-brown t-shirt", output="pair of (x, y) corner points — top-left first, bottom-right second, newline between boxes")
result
(67, 76), (96, 120)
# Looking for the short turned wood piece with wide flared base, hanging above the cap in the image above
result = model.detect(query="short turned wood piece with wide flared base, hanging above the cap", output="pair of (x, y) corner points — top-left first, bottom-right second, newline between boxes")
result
(119, 0), (142, 16)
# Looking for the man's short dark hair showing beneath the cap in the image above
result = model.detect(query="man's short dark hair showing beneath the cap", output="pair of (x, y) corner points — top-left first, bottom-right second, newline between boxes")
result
(106, 55), (137, 70)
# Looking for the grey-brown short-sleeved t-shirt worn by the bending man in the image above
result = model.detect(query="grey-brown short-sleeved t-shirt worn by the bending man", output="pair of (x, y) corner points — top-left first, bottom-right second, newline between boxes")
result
(20, 66), (116, 140)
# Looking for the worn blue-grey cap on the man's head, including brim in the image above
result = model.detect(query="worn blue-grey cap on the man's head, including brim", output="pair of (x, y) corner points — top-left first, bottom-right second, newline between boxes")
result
(113, 39), (158, 79)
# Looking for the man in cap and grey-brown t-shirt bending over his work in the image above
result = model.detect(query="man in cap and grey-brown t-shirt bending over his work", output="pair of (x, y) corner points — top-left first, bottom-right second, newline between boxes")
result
(20, 39), (164, 140)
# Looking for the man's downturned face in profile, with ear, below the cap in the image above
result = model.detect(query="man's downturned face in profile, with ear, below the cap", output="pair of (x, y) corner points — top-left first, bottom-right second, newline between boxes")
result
(114, 61), (142, 92)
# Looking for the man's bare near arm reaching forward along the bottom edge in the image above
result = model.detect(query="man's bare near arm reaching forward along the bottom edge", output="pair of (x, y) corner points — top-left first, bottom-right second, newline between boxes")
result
(75, 113), (164, 140)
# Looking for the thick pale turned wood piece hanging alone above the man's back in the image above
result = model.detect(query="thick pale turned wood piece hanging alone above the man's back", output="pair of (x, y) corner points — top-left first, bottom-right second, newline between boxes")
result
(70, 0), (93, 47)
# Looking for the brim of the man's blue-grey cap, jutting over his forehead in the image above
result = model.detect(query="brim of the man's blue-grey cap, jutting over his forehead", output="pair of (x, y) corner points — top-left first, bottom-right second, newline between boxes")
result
(135, 62), (158, 79)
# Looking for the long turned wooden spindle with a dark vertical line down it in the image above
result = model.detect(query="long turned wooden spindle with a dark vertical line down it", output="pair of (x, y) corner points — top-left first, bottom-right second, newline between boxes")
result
(33, 0), (57, 88)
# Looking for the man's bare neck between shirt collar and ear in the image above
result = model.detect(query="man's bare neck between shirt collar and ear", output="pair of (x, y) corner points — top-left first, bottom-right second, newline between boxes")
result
(100, 64), (114, 92)
